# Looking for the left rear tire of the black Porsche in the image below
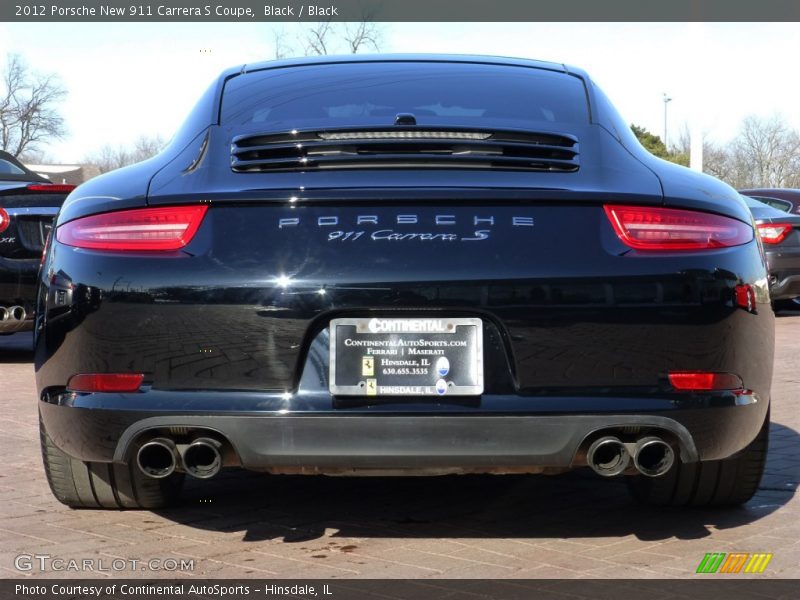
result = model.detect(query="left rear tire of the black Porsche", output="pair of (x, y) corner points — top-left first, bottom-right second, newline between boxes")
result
(39, 422), (183, 509)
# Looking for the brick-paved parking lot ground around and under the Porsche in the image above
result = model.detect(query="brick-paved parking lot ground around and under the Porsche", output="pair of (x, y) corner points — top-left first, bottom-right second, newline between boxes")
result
(0, 313), (800, 579)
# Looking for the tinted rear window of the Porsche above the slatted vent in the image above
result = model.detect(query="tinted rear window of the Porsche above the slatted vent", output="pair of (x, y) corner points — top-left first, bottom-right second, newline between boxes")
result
(221, 62), (589, 130)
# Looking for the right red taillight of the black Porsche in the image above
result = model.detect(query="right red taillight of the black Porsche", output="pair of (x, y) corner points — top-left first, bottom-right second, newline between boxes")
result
(605, 205), (753, 250)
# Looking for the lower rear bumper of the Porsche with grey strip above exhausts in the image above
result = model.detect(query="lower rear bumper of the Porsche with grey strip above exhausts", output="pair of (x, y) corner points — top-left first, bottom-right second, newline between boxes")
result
(39, 392), (768, 472)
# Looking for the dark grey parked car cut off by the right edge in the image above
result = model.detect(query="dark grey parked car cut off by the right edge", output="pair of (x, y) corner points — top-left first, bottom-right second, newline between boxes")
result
(742, 195), (800, 310)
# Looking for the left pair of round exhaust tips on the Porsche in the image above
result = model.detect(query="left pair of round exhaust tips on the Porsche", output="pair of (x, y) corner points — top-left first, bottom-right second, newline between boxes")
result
(136, 437), (222, 479)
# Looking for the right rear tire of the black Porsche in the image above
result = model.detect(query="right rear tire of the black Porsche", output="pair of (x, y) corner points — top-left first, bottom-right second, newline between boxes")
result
(627, 412), (769, 506)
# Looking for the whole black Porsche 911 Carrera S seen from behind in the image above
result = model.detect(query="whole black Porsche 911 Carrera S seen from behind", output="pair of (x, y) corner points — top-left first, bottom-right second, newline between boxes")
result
(36, 55), (774, 508)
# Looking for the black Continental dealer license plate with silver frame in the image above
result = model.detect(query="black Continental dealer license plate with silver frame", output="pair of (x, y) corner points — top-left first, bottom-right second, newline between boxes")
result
(330, 317), (483, 396)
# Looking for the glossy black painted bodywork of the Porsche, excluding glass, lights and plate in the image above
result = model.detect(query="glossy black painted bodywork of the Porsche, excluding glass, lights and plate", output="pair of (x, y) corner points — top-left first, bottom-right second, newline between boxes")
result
(36, 56), (773, 478)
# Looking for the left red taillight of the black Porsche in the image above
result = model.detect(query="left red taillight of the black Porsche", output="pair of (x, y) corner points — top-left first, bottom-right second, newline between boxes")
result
(56, 205), (208, 251)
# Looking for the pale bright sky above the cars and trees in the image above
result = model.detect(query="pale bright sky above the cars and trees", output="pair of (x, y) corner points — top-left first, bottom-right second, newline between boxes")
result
(0, 23), (800, 163)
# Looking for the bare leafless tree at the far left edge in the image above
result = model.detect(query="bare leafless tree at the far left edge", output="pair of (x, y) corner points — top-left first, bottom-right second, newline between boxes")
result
(0, 54), (67, 156)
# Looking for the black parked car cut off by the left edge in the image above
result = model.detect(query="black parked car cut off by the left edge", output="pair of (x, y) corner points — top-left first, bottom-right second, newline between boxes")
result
(0, 151), (75, 335)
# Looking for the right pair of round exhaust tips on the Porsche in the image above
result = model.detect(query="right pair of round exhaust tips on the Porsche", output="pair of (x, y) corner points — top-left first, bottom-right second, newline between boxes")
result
(586, 435), (675, 477)
